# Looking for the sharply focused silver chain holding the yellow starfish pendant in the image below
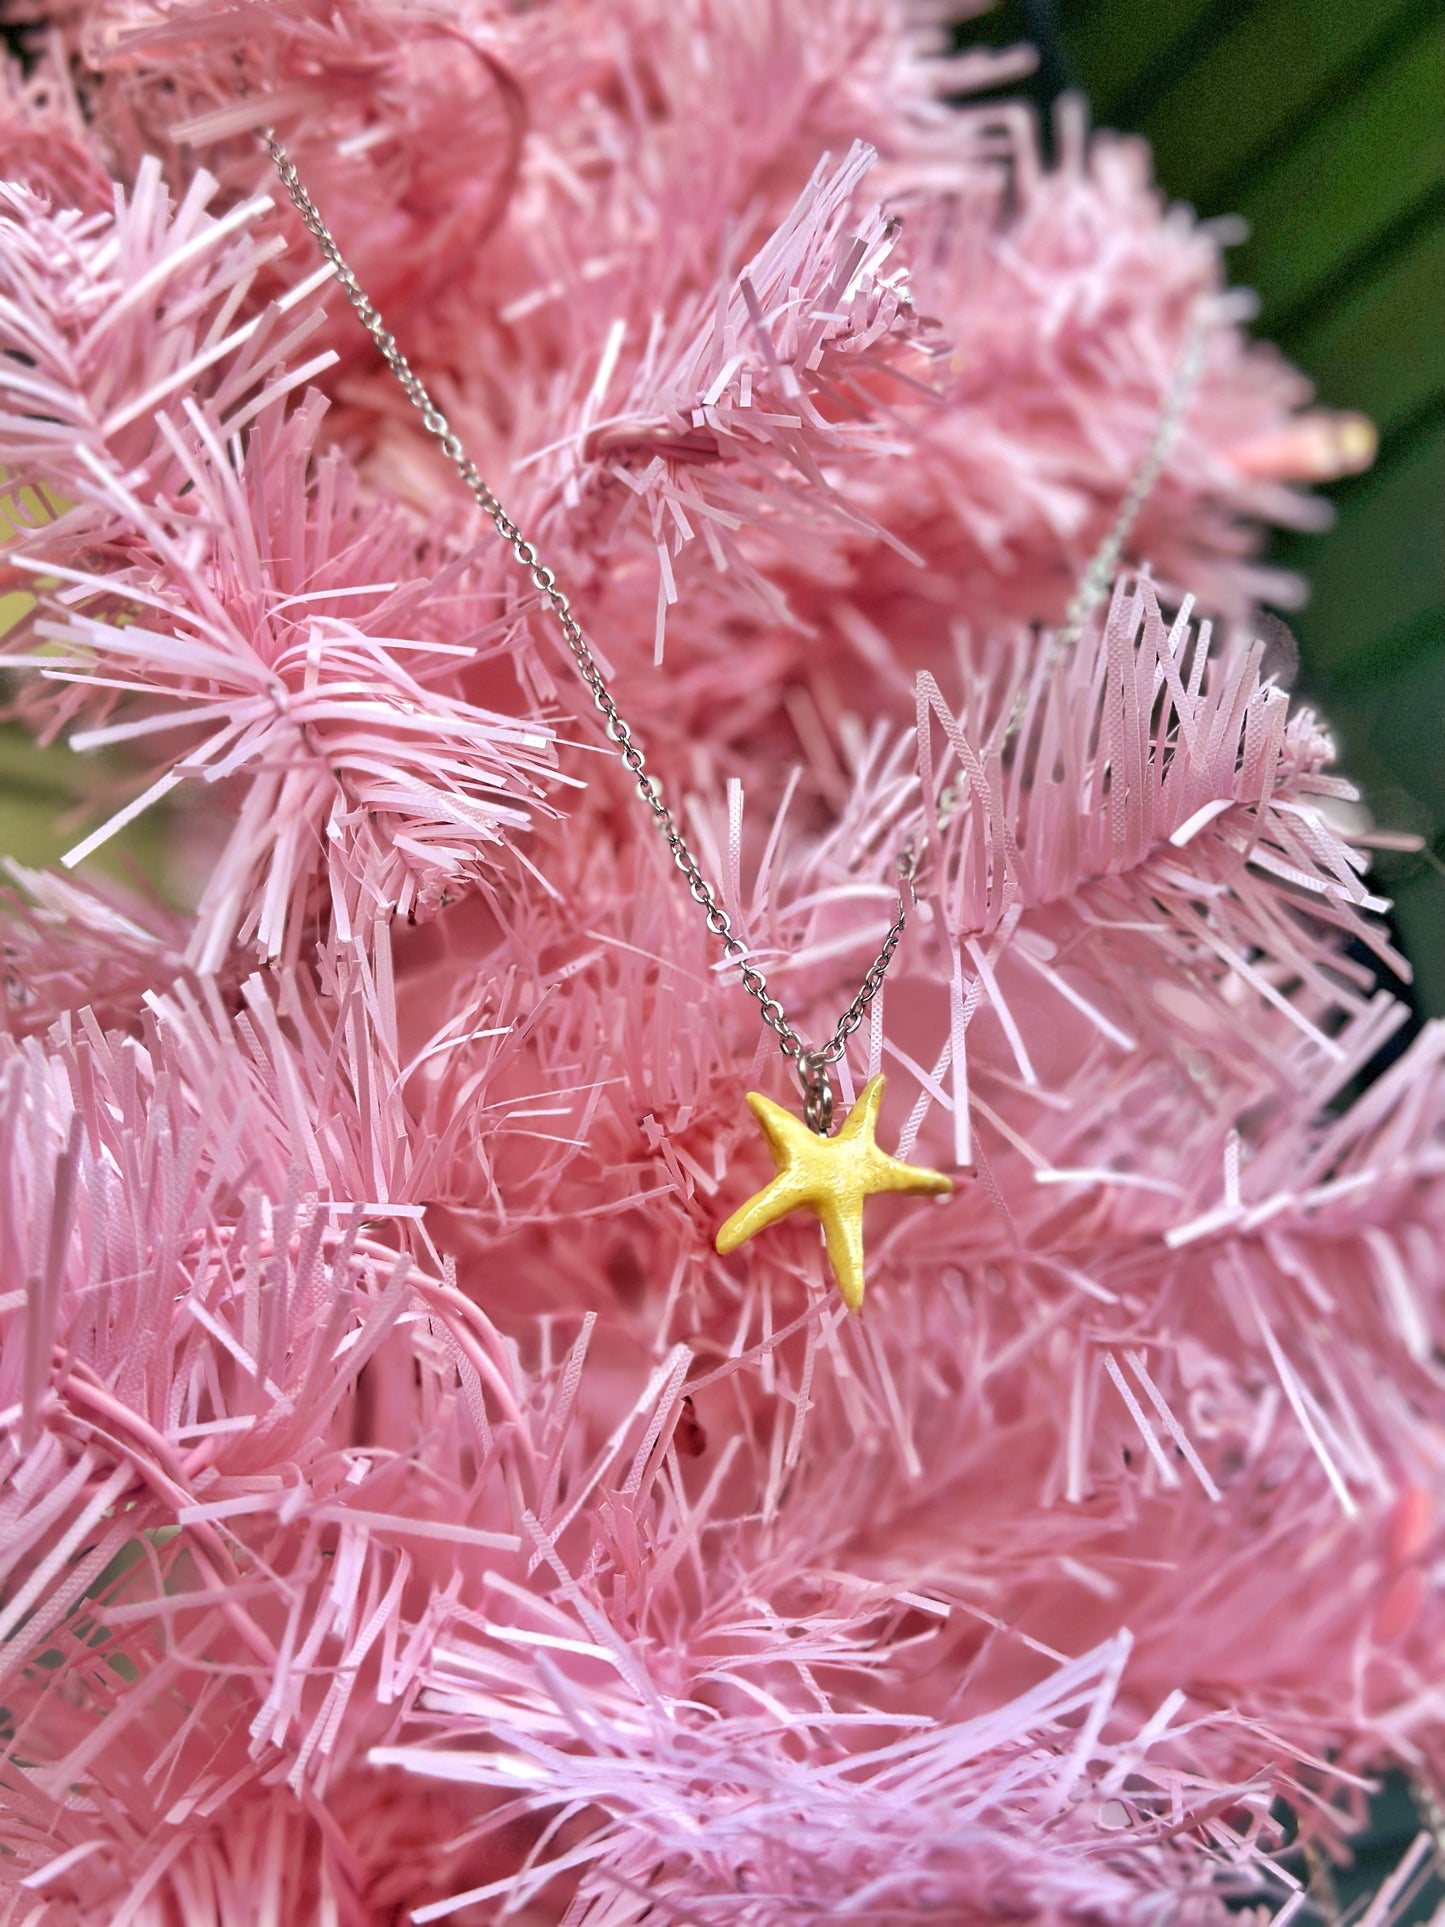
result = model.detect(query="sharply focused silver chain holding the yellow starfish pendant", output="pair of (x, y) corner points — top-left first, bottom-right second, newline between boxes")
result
(262, 129), (915, 1109)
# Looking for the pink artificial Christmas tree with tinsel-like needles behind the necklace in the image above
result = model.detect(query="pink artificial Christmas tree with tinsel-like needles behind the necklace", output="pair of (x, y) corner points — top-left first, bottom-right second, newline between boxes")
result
(0, 0), (1445, 1927)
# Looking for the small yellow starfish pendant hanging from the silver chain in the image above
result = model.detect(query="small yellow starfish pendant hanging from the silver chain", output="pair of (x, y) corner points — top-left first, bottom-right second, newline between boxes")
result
(717, 1077), (954, 1312)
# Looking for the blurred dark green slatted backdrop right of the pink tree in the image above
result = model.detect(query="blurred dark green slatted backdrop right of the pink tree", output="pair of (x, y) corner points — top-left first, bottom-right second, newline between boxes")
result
(978, 0), (1445, 1016)
